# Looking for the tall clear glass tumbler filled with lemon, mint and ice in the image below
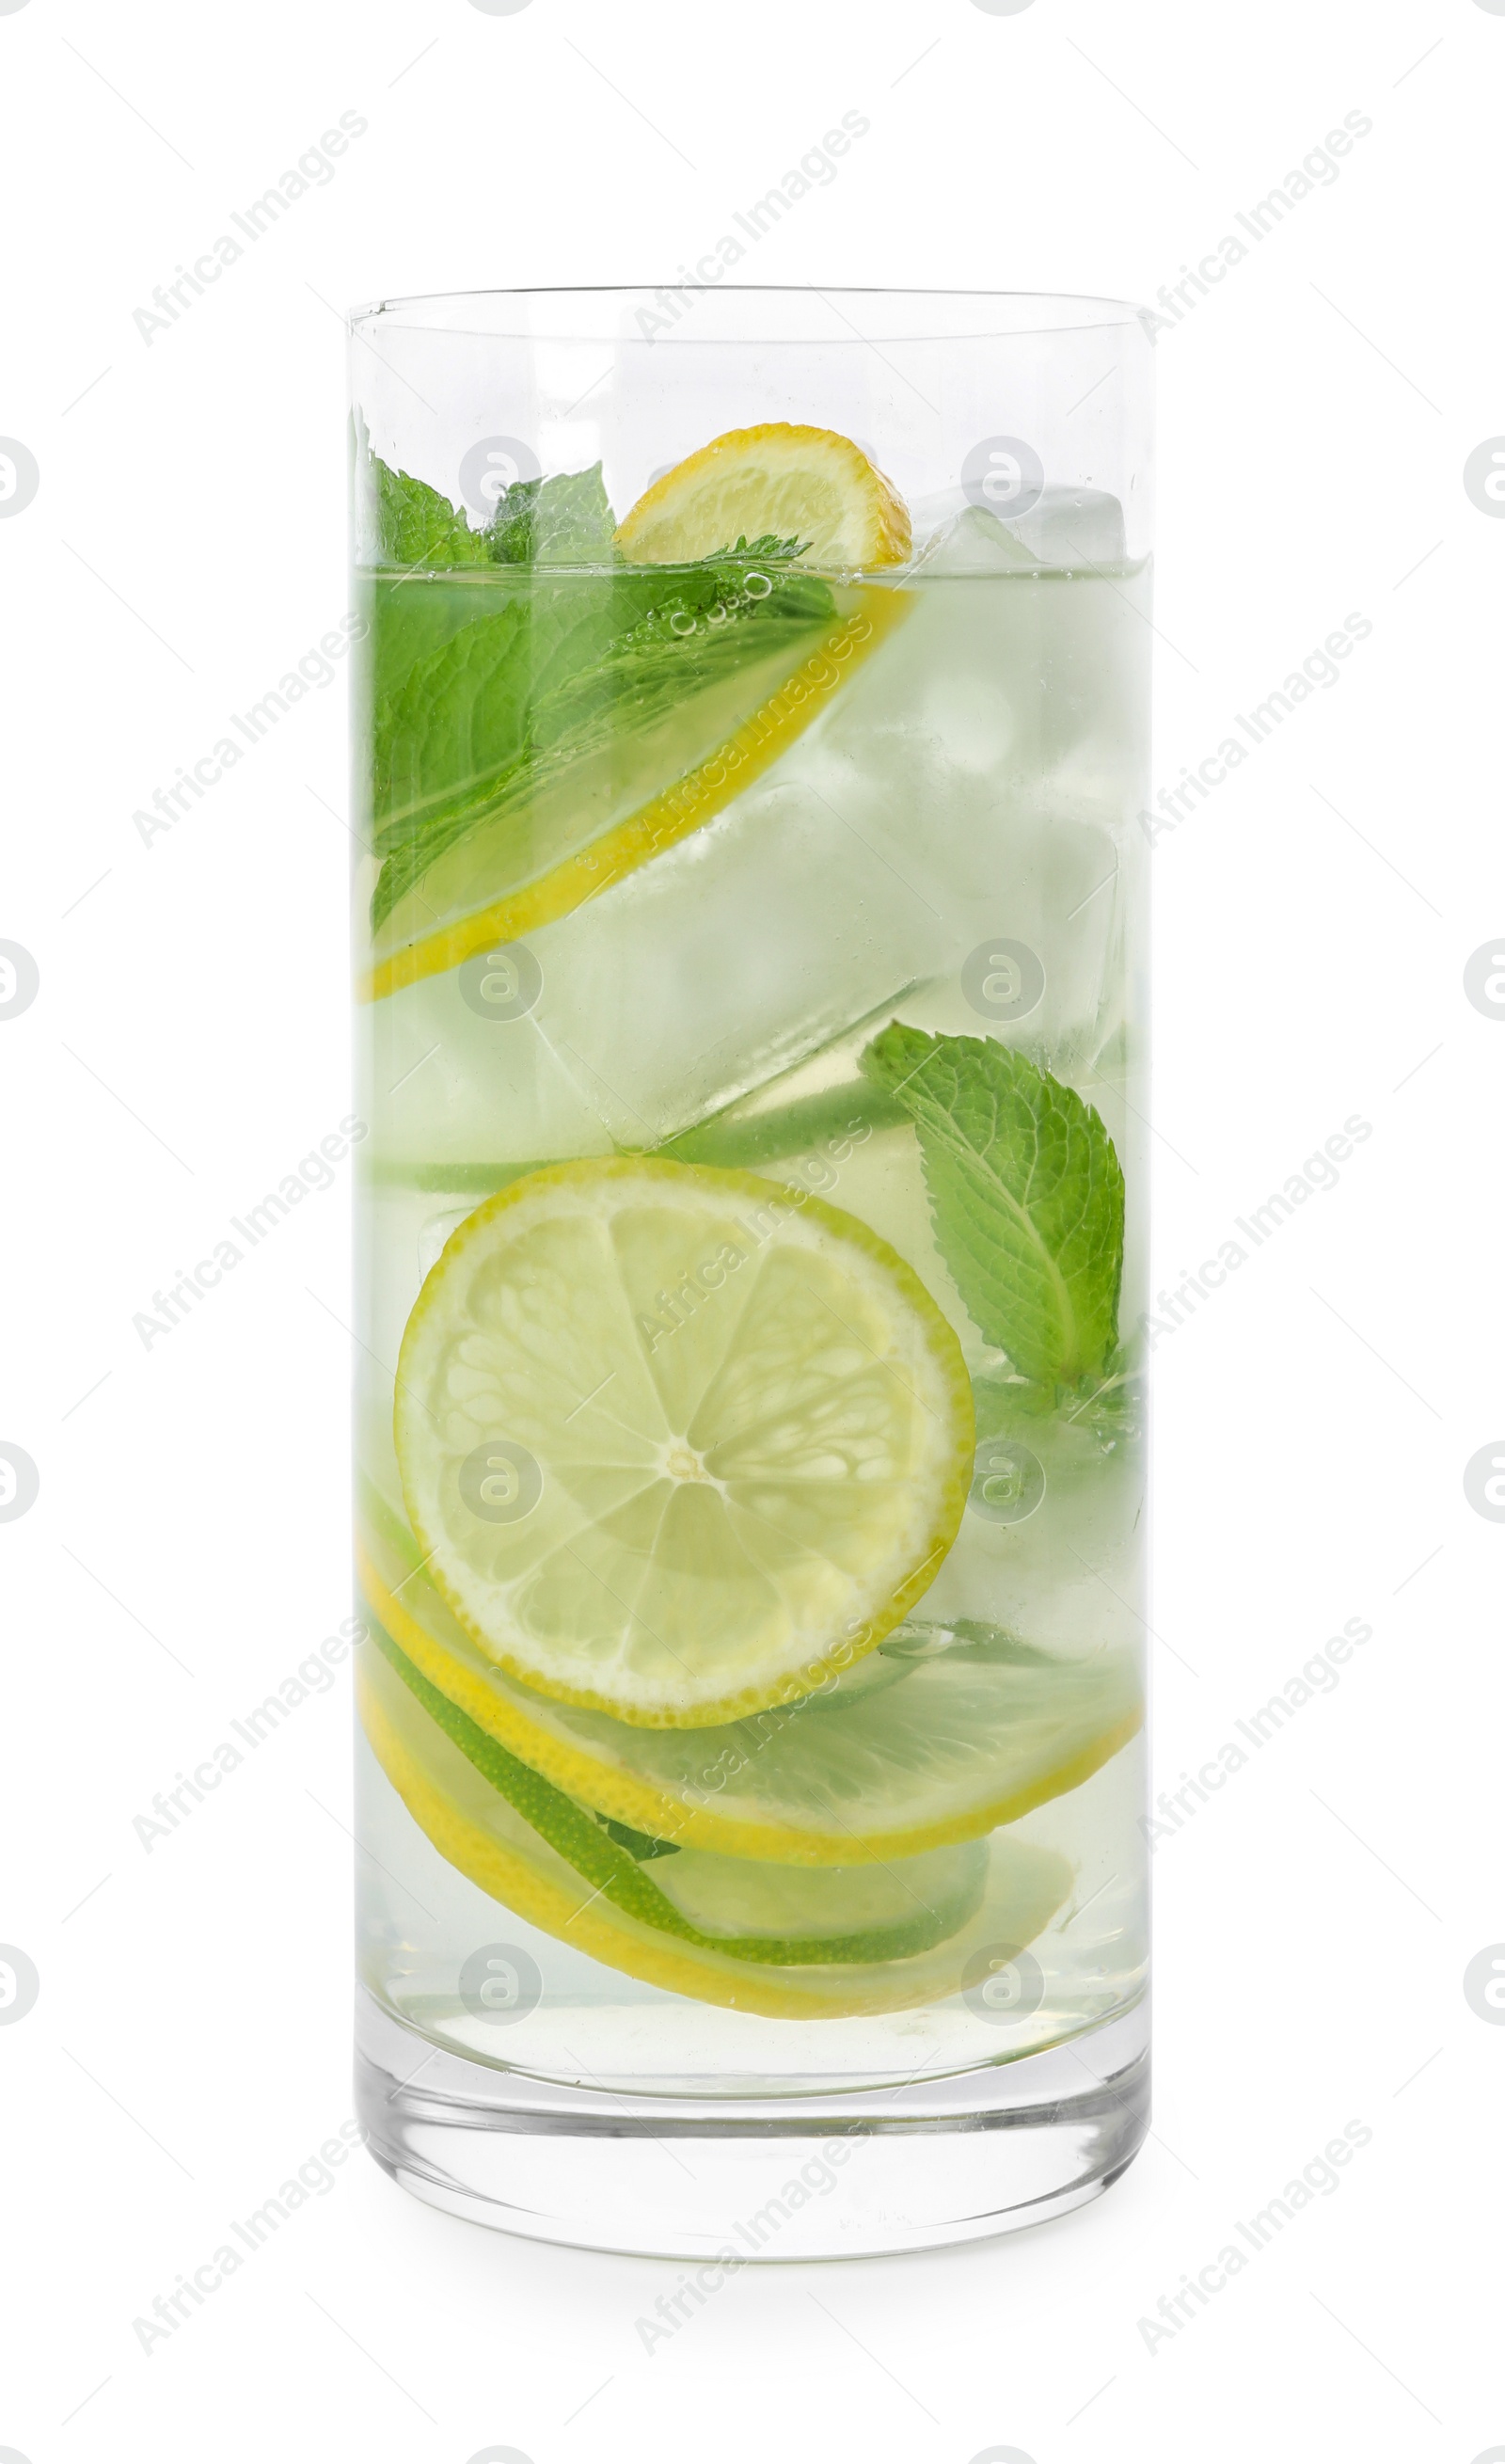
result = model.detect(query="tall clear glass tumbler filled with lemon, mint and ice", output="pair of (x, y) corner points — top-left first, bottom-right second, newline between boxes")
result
(352, 286), (1150, 2284)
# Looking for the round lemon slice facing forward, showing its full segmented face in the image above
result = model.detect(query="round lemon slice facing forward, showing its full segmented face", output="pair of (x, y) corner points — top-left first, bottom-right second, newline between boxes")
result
(394, 1158), (973, 1727)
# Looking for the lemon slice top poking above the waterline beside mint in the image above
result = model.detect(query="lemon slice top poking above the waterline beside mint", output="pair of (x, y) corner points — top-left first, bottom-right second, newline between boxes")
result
(616, 421), (909, 574)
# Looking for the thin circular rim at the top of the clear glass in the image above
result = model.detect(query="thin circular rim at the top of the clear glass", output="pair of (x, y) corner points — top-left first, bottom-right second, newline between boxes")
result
(345, 283), (1153, 350)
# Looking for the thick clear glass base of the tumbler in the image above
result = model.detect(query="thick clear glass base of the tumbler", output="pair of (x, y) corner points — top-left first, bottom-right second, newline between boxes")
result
(355, 1994), (1150, 2257)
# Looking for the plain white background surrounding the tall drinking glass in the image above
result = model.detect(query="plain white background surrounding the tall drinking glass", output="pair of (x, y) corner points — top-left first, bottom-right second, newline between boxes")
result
(0, 0), (1505, 2464)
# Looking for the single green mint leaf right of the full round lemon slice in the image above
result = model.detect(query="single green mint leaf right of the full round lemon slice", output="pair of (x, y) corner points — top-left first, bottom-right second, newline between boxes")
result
(863, 1023), (1123, 1387)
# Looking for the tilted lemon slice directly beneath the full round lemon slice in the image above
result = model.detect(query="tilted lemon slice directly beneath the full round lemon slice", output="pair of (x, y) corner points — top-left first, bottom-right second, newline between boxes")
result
(357, 1496), (1143, 1868)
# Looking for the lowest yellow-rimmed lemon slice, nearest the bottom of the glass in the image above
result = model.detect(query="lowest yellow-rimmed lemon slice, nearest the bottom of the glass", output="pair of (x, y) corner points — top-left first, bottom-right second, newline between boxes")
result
(357, 1648), (1074, 2018)
